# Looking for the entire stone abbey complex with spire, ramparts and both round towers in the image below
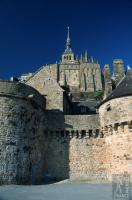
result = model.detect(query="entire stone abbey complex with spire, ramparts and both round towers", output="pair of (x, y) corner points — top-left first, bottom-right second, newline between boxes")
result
(0, 28), (132, 184)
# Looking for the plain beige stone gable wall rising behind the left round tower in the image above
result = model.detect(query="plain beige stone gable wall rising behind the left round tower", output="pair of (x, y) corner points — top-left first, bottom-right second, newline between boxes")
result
(26, 67), (63, 111)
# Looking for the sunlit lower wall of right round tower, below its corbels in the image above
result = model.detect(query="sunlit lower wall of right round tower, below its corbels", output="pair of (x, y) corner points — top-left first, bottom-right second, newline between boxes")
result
(105, 125), (132, 179)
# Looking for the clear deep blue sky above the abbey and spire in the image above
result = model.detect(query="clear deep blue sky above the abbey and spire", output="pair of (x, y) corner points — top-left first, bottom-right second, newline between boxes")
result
(0, 0), (132, 79)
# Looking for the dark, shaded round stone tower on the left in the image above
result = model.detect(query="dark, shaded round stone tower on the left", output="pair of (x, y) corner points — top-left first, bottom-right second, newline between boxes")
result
(0, 80), (45, 184)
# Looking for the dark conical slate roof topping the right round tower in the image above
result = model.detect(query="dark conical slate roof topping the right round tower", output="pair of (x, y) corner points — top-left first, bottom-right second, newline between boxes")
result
(97, 71), (132, 108)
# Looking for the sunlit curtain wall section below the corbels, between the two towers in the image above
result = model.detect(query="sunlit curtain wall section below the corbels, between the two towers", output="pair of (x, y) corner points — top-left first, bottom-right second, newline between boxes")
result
(69, 137), (107, 181)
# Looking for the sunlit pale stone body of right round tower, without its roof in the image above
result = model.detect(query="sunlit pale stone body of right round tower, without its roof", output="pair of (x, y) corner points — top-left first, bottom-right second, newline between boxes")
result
(99, 96), (132, 179)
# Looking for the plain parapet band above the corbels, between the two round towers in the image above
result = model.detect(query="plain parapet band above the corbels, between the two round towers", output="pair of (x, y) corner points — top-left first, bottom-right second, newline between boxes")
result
(46, 111), (100, 133)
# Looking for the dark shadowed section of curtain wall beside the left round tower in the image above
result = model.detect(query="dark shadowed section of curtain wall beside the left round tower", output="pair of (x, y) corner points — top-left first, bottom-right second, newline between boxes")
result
(44, 110), (71, 184)
